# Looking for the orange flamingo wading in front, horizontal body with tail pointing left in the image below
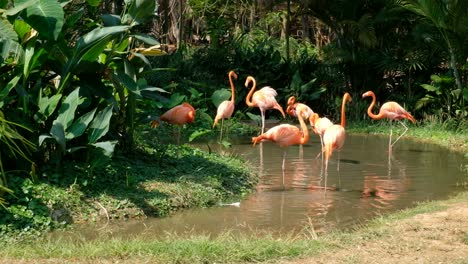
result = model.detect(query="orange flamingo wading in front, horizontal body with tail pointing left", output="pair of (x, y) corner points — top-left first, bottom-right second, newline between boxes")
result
(252, 107), (309, 186)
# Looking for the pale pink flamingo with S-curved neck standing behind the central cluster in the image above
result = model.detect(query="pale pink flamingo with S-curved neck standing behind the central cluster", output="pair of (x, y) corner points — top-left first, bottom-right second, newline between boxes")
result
(245, 76), (286, 134)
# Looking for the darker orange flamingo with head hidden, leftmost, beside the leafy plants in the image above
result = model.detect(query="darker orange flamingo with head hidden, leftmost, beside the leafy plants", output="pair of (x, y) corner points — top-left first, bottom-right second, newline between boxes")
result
(151, 102), (196, 143)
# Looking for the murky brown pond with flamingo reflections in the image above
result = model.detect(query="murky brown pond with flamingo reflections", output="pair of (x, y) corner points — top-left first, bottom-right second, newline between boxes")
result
(55, 135), (467, 238)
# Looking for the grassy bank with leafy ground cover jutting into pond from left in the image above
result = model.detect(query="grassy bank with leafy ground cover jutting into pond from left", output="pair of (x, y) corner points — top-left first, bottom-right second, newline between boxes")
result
(0, 125), (257, 242)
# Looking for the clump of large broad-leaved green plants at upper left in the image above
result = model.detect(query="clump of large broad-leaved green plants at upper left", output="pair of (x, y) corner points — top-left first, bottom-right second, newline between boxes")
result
(0, 0), (164, 178)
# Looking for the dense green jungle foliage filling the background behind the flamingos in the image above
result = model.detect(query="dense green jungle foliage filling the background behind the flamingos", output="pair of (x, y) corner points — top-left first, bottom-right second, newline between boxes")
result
(0, 0), (468, 234)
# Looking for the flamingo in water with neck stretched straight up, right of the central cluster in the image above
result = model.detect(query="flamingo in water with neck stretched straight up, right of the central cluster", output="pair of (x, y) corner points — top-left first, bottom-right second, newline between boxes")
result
(323, 93), (352, 170)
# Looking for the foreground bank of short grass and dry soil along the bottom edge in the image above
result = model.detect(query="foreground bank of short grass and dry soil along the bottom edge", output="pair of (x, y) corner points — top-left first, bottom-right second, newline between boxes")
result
(0, 193), (468, 263)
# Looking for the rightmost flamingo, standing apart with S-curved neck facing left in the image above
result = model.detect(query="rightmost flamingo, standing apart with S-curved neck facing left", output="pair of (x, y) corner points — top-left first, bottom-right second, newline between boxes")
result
(362, 91), (416, 148)
